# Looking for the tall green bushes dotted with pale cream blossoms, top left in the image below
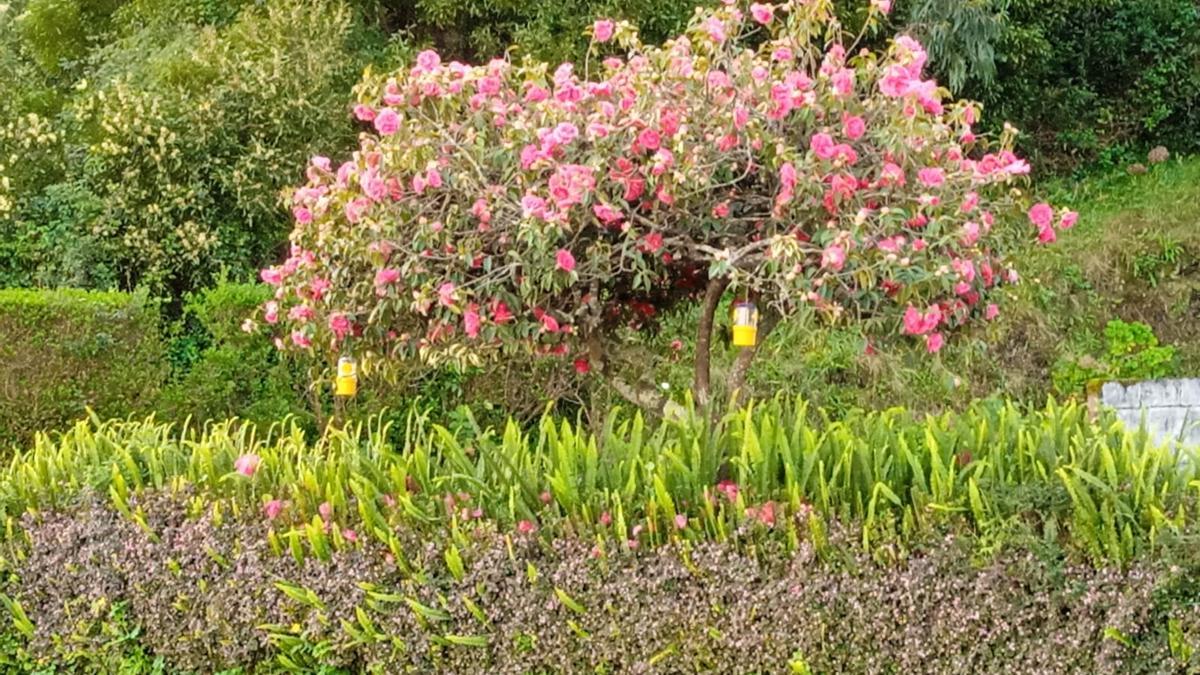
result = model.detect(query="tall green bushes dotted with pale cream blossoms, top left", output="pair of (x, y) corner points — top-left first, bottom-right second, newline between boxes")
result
(0, 0), (379, 298)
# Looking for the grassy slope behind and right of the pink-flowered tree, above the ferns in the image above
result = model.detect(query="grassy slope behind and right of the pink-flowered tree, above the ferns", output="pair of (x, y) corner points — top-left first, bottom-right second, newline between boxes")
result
(700, 159), (1200, 410)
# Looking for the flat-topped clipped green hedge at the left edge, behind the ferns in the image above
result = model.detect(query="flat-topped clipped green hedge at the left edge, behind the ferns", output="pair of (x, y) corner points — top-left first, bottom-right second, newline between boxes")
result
(0, 284), (166, 446)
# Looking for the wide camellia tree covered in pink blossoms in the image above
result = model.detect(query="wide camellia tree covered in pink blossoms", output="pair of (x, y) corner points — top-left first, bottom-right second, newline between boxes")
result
(262, 0), (1076, 408)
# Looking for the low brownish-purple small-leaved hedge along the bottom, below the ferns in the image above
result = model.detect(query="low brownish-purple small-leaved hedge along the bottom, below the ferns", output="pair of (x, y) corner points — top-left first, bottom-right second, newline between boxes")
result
(8, 492), (1200, 673)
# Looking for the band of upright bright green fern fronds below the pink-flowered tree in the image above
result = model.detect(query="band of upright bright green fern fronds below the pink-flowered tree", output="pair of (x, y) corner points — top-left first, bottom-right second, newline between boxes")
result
(0, 400), (1198, 563)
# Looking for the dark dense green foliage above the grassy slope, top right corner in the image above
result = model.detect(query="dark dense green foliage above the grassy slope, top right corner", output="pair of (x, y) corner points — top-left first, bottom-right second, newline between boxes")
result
(952, 0), (1200, 166)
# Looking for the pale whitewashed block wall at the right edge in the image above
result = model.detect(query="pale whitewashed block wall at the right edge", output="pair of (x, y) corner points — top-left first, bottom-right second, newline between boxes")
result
(1100, 378), (1200, 448)
